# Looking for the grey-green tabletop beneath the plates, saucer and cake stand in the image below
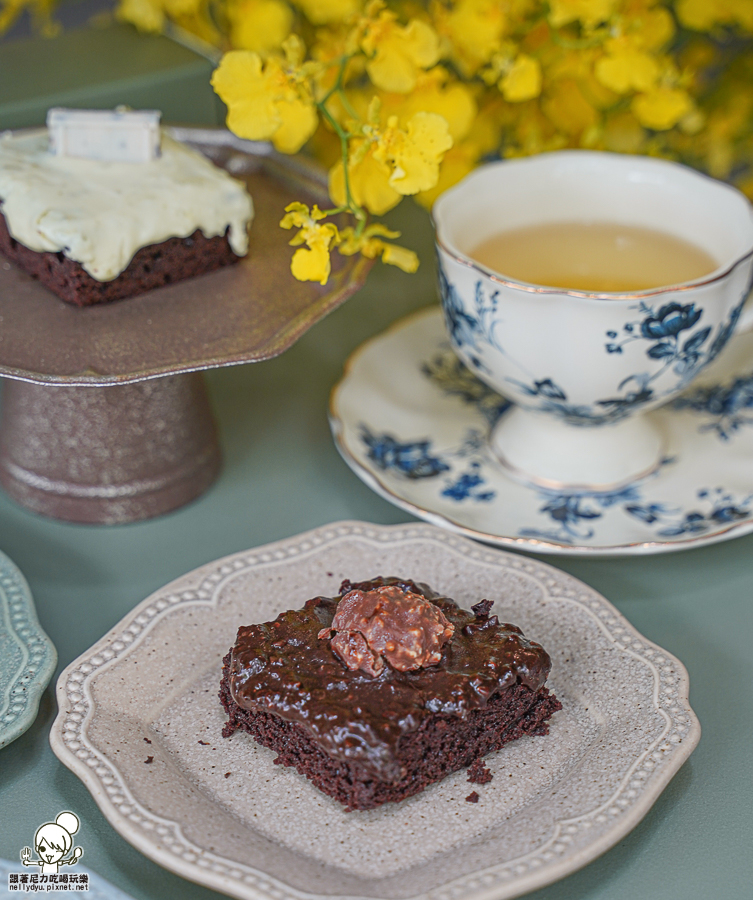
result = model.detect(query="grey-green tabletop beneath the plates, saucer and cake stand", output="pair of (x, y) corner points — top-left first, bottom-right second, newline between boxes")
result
(0, 26), (753, 900)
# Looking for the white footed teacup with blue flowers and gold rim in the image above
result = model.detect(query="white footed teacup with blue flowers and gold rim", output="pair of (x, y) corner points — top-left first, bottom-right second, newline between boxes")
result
(433, 150), (753, 490)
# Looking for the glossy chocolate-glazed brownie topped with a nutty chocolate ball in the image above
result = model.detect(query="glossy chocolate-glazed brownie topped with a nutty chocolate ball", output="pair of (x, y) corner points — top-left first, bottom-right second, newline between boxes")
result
(220, 577), (562, 810)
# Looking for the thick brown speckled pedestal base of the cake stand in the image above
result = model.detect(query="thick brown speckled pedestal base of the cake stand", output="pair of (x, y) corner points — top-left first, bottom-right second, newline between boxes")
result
(0, 372), (220, 524)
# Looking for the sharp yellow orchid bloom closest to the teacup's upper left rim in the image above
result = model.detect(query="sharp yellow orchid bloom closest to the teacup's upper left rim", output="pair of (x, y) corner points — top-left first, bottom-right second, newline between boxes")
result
(374, 112), (452, 195)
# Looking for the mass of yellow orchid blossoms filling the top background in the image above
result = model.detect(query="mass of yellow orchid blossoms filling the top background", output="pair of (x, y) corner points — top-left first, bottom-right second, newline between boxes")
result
(0, 0), (753, 281)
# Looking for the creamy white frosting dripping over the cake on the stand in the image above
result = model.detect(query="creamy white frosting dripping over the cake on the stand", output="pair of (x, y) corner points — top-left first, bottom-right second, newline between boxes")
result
(0, 129), (254, 281)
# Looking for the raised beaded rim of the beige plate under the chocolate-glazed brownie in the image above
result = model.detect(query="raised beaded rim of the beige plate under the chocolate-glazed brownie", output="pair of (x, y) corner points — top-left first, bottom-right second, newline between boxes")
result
(50, 522), (700, 900)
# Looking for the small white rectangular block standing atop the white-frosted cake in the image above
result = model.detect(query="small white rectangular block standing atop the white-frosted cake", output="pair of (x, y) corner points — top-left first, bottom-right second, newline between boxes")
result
(47, 108), (160, 163)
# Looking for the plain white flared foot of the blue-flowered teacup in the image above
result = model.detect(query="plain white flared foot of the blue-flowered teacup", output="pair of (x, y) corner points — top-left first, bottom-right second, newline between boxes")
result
(490, 406), (665, 492)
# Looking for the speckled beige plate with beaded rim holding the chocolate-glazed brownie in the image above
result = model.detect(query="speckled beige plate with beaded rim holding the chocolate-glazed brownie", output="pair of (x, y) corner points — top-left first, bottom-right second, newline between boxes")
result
(50, 522), (700, 900)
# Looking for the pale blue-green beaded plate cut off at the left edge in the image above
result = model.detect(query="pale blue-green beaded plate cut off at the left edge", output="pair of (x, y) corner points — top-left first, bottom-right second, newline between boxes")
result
(0, 553), (57, 747)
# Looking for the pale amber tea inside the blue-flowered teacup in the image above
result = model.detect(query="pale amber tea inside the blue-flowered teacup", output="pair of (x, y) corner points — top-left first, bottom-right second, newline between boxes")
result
(468, 222), (719, 293)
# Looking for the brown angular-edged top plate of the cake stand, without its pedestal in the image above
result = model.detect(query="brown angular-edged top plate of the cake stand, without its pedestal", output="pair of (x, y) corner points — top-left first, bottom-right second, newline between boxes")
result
(0, 128), (370, 385)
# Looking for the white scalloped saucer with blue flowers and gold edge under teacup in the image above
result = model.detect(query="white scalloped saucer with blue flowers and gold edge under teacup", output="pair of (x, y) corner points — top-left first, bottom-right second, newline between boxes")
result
(330, 307), (753, 556)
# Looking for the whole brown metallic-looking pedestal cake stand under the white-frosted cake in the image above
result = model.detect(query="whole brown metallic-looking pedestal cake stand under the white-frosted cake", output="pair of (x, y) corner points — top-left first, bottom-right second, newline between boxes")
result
(0, 128), (370, 524)
